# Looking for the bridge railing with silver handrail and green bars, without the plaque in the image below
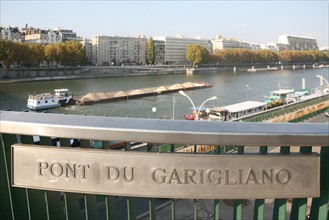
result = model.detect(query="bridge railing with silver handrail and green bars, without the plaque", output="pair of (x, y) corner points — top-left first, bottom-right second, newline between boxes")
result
(0, 111), (329, 219)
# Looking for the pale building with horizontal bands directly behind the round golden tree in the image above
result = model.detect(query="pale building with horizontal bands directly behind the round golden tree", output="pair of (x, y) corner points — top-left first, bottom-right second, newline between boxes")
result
(154, 36), (212, 65)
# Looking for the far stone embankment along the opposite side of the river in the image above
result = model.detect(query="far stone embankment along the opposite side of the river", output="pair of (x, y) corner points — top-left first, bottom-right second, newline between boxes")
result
(0, 63), (328, 84)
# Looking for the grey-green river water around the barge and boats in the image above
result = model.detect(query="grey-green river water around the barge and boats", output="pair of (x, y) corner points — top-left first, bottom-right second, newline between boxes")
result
(0, 68), (329, 119)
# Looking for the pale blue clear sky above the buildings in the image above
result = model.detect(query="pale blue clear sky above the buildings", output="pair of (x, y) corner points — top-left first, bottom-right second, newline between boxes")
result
(0, 0), (329, 47)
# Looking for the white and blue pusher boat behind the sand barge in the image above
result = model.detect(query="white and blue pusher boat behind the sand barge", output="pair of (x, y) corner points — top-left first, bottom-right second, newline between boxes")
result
(27, 89), (73, 110)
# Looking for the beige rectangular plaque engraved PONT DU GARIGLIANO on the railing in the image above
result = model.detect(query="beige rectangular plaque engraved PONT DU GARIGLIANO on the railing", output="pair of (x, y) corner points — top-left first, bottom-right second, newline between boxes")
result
(12, 144), (320, 199)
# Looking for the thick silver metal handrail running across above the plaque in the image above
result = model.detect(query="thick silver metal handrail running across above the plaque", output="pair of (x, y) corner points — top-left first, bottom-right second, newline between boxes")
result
(0, 111), (329, 146)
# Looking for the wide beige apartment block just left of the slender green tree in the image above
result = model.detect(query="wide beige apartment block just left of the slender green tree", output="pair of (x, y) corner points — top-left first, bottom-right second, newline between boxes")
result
(91, 36), (147, 65)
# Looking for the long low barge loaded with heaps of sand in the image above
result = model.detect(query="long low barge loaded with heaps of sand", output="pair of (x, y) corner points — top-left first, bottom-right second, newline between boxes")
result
(74, 82), (211, 105)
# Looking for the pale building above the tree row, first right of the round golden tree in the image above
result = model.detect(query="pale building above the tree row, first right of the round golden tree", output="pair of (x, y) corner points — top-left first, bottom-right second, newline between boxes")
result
(211, 35), (252, 52)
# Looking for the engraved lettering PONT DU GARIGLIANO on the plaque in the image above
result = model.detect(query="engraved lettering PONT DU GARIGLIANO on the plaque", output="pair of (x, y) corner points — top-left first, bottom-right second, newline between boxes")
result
(38, 161), (292, 185)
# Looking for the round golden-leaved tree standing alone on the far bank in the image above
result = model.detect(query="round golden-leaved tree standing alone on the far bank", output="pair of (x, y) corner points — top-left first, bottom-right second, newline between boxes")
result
(185, 44), (209, 68)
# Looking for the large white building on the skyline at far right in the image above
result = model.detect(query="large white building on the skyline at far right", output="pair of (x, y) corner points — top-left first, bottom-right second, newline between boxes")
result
(279, 34), (319, 50)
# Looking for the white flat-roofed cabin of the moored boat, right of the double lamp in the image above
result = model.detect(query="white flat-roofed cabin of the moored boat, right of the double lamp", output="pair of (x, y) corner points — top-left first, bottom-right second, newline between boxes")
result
(209, 101), (267, 121)
